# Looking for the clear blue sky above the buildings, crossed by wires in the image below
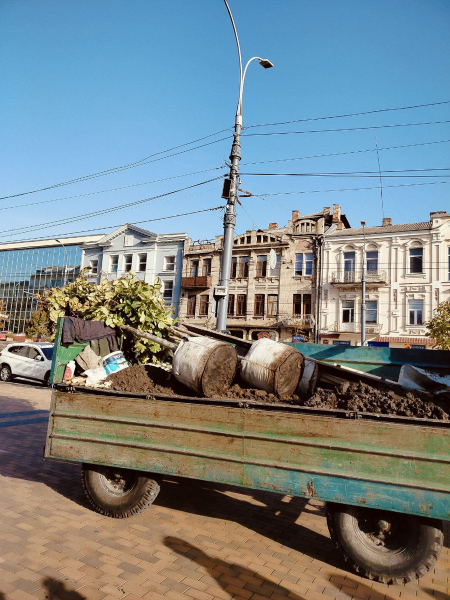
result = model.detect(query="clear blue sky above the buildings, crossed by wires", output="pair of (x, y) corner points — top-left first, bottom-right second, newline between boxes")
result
(0, 0), (450, 243)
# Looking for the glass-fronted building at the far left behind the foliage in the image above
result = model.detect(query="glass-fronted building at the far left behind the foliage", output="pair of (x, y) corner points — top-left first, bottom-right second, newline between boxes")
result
(0, 243), (82, 333)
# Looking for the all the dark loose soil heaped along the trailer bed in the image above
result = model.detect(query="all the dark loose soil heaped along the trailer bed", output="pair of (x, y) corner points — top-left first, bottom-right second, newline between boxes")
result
(106, 365), (449, 420)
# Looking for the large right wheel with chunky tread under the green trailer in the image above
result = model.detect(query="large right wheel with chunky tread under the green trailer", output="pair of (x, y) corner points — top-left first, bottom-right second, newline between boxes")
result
(327, 503), (444, 584)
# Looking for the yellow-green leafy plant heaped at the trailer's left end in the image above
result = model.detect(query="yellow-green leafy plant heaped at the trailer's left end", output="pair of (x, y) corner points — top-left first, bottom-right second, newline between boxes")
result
(40, 272), (175, 363)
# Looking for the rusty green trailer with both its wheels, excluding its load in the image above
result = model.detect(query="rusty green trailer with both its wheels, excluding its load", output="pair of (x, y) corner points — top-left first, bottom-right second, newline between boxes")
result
(45, 324), (450, 583)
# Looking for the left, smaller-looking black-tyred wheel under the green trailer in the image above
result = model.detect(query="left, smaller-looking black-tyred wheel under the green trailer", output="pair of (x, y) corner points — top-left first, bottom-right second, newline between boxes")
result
(81, 464), (160, 519)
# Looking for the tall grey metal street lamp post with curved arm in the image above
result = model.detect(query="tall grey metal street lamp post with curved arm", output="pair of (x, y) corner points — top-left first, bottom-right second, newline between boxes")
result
(215, 0), (273, 331)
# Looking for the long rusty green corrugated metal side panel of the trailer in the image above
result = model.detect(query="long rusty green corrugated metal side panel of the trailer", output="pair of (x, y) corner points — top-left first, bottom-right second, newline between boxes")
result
(45, 391), (450, 519)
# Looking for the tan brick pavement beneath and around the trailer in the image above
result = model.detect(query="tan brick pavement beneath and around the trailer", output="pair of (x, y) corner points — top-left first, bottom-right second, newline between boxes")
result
(0, 383), (450, 600)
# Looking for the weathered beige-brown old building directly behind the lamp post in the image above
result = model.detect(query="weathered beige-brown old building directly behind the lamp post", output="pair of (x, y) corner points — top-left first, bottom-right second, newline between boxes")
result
(179, 205), (349, 341)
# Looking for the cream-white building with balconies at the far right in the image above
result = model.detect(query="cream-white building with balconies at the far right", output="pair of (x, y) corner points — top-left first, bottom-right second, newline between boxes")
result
(319, 211), (450, 348)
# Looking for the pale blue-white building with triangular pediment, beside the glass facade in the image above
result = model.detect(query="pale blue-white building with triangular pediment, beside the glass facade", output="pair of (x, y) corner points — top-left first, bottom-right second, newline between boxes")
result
(82, 224), (187, 315)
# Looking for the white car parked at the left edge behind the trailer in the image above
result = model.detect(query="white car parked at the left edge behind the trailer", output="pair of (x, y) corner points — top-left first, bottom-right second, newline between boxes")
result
(0, 342), (53, 385)
